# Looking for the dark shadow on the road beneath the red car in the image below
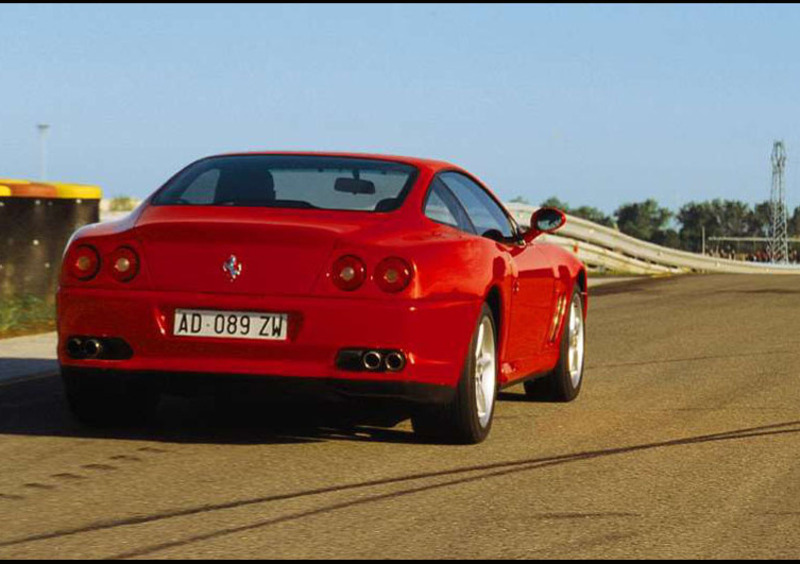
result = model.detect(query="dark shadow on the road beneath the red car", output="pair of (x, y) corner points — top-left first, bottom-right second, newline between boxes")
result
(0, 373), (438, 444)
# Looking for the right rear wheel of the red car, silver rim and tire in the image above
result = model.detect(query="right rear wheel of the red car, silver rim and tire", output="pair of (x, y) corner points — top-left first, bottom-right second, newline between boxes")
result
(411, 304), (498, 444)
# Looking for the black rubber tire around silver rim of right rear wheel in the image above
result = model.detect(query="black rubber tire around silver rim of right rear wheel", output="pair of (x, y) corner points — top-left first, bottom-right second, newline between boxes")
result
(411, 304), (499, 444)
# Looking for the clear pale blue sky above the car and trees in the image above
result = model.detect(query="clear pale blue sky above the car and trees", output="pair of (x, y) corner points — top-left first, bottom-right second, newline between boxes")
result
(0, 4), (800, 212)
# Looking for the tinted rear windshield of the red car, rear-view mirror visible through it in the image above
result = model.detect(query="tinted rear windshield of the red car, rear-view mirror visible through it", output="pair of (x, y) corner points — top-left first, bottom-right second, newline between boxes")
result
(153, 155), (417, 212)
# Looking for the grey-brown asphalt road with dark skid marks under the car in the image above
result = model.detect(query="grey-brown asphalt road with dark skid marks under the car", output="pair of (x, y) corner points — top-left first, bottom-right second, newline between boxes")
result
(0, 276), (800, 558)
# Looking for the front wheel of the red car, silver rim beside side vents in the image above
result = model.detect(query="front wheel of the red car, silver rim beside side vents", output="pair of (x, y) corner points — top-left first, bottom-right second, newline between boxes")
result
(525, 290), (586, 402)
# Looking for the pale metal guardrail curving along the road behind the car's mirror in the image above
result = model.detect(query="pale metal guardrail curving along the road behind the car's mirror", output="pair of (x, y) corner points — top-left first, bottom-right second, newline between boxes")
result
(507, 204), (800, 275)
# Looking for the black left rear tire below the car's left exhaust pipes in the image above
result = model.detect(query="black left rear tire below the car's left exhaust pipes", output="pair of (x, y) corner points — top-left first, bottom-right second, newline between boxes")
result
(61, 370), (159, 428)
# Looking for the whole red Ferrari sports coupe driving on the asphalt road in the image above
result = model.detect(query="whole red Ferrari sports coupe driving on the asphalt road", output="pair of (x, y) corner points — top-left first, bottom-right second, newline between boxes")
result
(58, 153), (587, 443)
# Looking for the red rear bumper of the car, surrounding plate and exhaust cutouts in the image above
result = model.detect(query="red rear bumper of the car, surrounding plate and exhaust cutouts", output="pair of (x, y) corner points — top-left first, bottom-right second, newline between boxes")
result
(58, 288), (480, 395)
